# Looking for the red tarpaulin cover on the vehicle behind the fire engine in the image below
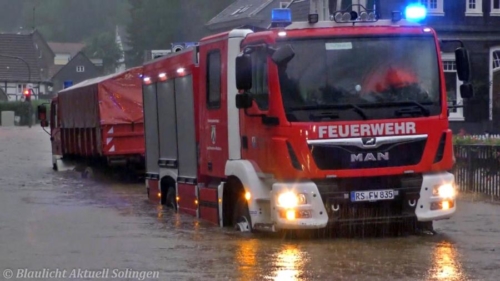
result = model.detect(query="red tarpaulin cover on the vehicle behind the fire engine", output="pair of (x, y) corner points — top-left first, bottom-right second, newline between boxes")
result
(58, 67), (144, 128)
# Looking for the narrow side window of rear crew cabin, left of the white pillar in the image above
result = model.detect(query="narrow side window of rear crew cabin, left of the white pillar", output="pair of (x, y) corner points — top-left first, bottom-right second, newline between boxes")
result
(207, 50), (222, 108)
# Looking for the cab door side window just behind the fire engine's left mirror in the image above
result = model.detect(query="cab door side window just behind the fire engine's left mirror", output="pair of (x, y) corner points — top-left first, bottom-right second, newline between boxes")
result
(249, 48), (269, 110)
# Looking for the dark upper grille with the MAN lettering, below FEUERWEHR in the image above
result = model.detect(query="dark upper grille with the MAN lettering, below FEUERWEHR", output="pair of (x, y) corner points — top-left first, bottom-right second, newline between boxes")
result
(309, 139), (427, 170)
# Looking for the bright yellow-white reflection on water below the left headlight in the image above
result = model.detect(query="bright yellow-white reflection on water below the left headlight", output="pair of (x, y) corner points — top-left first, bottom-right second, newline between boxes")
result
(272, 245), (306, 280)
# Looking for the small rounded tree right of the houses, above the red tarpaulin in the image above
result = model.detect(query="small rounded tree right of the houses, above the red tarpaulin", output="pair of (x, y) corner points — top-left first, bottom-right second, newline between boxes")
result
(83, 32), (122, 74)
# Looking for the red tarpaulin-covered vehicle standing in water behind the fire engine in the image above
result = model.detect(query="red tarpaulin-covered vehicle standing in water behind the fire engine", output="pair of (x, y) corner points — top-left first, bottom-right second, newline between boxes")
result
(38, 67), (144, 175)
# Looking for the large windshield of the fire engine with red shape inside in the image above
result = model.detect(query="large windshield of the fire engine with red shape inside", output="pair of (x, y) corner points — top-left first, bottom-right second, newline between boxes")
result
(279, 37), (440, 121)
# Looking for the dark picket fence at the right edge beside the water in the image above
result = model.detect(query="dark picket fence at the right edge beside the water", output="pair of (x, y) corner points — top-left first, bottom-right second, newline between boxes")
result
(454, 135), (500, 197)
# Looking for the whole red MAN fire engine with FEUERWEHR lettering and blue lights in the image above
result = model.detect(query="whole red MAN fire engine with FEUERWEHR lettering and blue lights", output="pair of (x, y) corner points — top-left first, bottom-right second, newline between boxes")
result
(143, 3), (473, 231)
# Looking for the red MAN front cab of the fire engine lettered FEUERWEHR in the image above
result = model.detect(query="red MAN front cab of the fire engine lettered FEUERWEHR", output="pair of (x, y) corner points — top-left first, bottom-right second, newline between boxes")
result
(230, 6), (472, 229)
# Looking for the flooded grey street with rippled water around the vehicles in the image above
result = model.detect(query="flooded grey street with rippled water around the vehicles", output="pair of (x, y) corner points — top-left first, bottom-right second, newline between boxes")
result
(0, 127), (500, 280)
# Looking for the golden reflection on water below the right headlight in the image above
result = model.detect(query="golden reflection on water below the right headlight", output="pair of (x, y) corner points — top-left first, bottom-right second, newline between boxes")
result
(429, 238), (467, 280)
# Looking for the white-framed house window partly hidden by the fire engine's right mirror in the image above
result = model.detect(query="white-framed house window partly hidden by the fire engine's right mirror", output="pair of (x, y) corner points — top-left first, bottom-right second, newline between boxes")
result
(442, 53), (464, 121)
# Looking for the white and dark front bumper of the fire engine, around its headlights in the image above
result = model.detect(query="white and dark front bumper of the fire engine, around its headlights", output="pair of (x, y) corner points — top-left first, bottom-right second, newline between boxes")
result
(271, 173), (456, 229)
